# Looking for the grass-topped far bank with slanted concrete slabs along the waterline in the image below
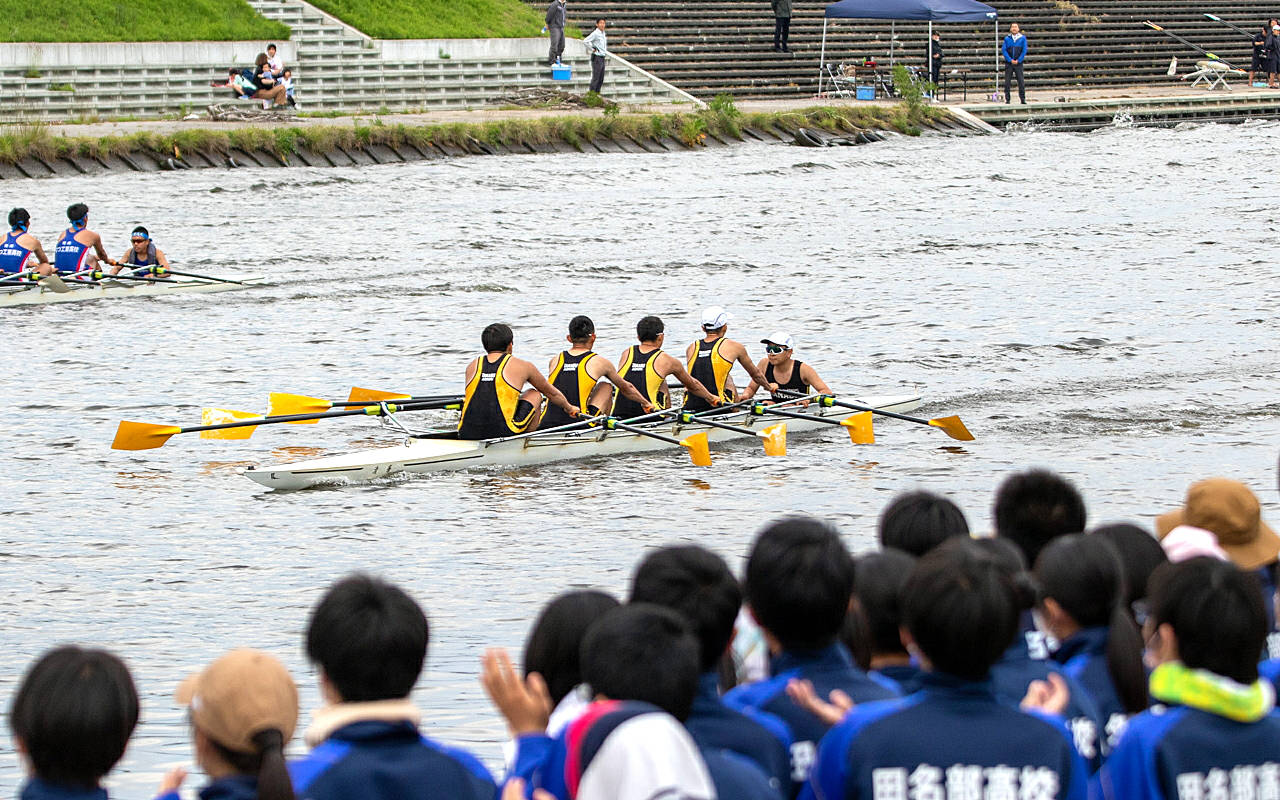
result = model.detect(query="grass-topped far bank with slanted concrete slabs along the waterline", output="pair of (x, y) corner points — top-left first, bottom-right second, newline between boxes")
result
(0, 102), (991, 179)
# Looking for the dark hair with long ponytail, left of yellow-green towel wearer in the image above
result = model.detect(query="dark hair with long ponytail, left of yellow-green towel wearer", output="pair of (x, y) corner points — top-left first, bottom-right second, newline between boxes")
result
(1036, 534), (1148, 714)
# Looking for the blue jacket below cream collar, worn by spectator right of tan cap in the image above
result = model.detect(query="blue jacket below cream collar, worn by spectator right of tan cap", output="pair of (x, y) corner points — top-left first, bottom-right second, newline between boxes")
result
(289, 721), (498, 800)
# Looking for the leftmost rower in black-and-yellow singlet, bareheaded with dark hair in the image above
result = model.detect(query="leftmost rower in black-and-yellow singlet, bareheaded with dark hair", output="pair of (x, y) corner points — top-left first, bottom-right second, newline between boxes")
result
(458, 323), (579, 439)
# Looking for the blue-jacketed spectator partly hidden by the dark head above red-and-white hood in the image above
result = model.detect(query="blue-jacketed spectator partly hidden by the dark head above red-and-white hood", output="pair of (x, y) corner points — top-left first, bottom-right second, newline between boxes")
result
(631, 544), (791, 792)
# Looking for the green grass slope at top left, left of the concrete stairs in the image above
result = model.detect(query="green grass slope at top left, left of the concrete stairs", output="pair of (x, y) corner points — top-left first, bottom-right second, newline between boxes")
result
(0, 0), (289, 42)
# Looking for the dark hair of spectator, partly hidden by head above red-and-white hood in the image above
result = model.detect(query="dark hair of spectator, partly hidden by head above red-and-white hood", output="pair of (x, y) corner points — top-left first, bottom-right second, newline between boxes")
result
(631, 544), (742, 672)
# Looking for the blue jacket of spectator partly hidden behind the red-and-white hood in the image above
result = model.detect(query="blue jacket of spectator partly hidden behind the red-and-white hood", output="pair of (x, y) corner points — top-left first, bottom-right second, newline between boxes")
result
(685, 672), (791, 792)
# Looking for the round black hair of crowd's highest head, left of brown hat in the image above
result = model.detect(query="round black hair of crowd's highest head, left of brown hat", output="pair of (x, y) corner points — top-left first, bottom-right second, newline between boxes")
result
(995, 470), (1085, 564)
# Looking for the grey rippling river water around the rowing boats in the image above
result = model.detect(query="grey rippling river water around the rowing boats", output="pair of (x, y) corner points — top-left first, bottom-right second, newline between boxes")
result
(0, 118), (1280, 797)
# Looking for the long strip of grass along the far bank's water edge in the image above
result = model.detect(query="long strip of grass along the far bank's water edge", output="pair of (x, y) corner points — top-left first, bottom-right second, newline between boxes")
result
(0, 101), (943, 164)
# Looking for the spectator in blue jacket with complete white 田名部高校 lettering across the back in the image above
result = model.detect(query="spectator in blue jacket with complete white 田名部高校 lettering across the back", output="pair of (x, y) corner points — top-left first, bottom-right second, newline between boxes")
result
(801, 539), (1089, 800)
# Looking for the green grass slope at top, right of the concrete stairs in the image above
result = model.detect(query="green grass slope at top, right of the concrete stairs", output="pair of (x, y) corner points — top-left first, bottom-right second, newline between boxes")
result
(311, 0), (543, 38)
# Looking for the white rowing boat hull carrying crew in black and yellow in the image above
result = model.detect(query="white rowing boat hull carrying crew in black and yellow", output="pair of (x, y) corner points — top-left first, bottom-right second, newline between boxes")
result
(243, 394), (922, 489)
